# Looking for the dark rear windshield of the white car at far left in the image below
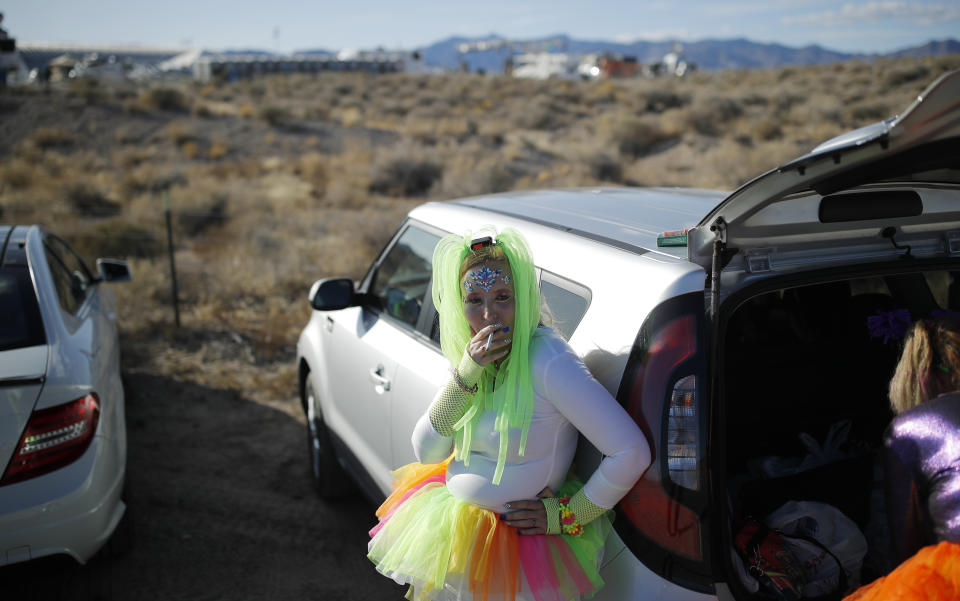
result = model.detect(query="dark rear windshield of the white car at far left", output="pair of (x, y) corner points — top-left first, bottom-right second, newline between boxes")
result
(0, 267), (46, 351)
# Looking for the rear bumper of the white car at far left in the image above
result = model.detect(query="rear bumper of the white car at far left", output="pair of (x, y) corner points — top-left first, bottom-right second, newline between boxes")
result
(0, 436), (126, 566)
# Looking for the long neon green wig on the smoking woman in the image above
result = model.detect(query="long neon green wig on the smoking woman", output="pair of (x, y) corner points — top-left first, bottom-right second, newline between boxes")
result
(433, 226), (540, 484)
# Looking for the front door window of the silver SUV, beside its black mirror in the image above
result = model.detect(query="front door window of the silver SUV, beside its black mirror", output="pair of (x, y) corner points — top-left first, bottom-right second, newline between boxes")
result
(370, 225), (440, 328)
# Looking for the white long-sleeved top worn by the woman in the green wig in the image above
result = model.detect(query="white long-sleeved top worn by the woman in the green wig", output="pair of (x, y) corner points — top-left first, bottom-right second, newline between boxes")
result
(412, 328), (650, 512)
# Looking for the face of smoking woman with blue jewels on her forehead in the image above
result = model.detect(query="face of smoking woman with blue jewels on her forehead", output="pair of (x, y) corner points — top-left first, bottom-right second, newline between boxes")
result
(460, 260), (516, 336)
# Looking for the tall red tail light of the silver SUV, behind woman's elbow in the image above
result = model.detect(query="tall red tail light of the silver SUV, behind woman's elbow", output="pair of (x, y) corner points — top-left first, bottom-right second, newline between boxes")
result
(615, 294), (713, 592)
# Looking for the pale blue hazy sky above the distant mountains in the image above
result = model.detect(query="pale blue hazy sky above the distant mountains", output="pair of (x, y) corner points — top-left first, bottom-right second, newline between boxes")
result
(0, 0), (960, 52)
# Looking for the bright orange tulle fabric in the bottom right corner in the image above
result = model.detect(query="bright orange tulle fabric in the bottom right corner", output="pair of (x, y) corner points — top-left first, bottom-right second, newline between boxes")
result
(843, 542), (960, 601)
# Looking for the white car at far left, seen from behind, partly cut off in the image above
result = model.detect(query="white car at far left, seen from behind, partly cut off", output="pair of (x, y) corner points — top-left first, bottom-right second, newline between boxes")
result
(0, 226), (130, 565)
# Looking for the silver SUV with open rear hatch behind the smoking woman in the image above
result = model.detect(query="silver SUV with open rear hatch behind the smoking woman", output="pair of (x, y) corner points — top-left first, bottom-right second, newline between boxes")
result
(297, 72), (960, 601)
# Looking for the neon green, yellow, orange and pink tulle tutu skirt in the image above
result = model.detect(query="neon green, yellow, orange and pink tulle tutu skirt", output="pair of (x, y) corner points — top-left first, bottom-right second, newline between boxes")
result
(367, 459), (610, 601)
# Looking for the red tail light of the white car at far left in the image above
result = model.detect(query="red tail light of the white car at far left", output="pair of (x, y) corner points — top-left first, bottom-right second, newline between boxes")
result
(0, 392), (100, 486)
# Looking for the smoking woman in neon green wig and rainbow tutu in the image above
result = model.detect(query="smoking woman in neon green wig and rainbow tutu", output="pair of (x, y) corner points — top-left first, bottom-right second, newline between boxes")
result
(368, 229), (650, 601)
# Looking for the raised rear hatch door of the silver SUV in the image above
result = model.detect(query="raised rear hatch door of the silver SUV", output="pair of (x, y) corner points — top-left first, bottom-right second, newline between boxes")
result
(688, 71), (960, 294)
